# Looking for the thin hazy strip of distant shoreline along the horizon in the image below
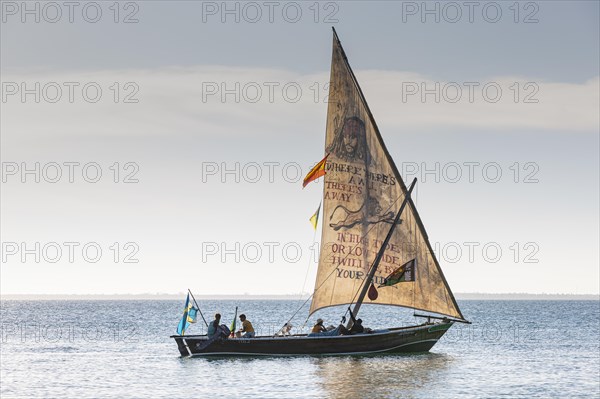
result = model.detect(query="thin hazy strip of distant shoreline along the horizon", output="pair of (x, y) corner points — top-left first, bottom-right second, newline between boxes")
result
(0, 293), (600, 301)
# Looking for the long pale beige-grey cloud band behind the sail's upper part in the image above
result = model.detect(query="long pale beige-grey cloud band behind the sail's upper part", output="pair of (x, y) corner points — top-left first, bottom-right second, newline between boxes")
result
(2, 66), (600, 147)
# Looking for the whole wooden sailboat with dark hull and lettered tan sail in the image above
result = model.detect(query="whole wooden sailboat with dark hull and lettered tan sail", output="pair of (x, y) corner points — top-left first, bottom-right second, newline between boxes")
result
(171, 29), (469, 356)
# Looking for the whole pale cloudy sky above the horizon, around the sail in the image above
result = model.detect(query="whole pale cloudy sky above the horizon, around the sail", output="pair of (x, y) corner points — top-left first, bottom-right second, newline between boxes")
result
(0, 0), (600, 295)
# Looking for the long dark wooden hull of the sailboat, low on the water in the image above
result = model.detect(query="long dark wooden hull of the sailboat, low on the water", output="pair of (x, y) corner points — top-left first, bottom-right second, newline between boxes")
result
(171, 322), (453, 356)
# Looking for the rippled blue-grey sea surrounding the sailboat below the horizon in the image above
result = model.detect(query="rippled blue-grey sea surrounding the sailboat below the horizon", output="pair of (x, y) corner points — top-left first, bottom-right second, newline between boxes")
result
(0, 298), (600, 399)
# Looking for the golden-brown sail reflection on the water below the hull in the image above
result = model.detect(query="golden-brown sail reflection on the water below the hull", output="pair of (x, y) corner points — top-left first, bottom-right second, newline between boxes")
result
(312, 353), (452, 399)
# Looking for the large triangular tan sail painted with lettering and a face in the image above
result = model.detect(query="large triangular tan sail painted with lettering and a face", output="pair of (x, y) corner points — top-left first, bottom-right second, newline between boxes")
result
(310, 31), (463, 319)
